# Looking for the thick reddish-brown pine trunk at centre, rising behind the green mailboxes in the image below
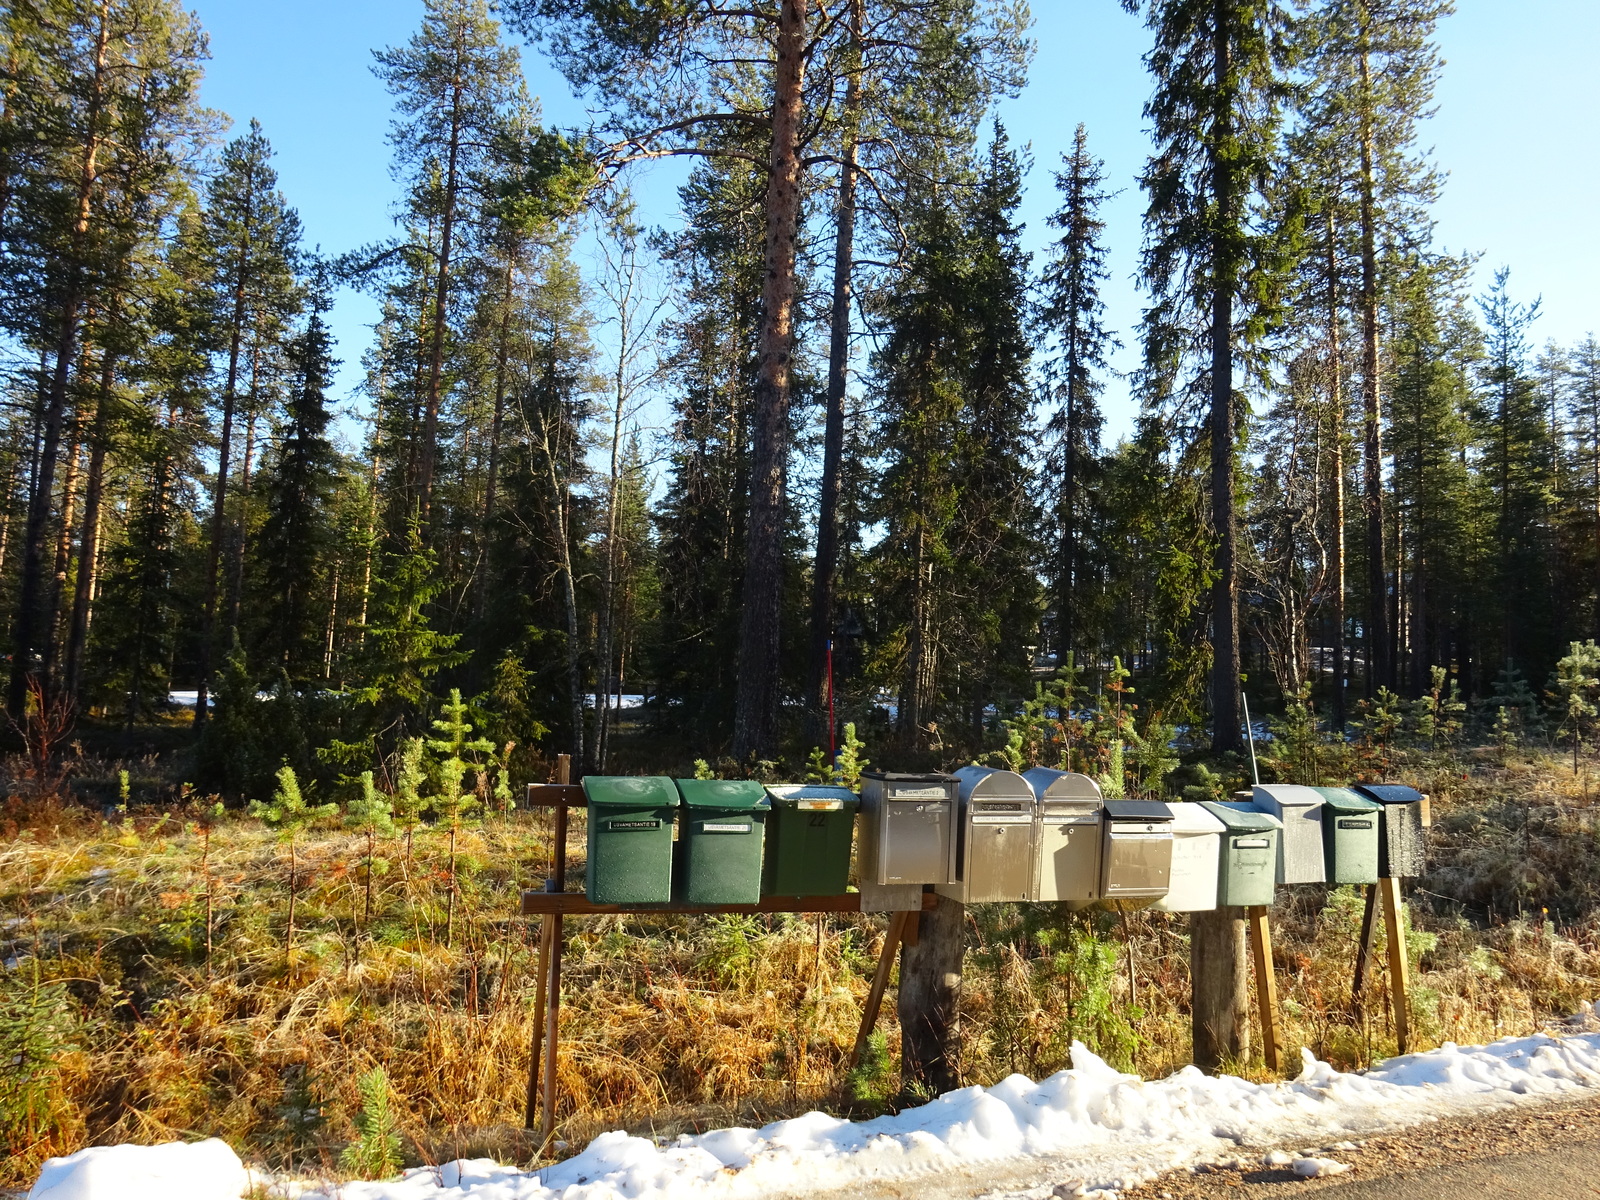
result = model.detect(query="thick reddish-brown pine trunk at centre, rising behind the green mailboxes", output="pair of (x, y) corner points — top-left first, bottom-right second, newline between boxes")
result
(733, 0), (810, 760)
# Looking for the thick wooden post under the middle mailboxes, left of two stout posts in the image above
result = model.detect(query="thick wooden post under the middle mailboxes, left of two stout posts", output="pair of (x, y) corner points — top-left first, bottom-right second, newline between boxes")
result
(898, 896), (966, 1098)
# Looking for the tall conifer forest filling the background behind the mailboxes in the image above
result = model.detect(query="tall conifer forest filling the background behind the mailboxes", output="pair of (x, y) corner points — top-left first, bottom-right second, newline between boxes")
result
(0, 0), (1600, 798)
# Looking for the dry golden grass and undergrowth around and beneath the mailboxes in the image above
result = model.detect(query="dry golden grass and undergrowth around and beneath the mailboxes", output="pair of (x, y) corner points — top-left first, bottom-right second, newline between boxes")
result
(0, 738), (1600, 1186)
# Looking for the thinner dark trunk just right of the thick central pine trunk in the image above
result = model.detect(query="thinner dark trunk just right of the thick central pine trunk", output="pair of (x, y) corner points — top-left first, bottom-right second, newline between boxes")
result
(808, 0), (864, 744)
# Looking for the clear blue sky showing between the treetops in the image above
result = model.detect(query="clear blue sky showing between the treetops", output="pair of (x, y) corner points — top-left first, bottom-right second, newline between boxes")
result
(192, 0), (1600, 448)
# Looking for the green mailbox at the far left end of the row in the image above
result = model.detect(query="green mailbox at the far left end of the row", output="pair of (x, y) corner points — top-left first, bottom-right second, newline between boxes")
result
(584, 774), (678, 904)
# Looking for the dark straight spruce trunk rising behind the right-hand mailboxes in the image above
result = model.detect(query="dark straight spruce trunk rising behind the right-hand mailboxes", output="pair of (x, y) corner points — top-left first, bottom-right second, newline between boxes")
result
(1211, 0), (1243, 750)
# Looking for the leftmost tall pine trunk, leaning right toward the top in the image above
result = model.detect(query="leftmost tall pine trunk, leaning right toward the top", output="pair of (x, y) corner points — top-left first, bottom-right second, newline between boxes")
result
(6, 0), (110, 717)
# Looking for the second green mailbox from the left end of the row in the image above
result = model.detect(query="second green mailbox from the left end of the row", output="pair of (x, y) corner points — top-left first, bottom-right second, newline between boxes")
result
(677, 779), (771, 904)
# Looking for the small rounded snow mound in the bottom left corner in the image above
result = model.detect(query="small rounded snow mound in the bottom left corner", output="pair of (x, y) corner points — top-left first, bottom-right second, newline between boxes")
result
(27, 1138), (250, 1200)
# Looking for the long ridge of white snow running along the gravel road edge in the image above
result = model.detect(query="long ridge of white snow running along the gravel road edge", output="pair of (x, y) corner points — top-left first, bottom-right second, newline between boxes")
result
(21, 1034), (1600, 1200)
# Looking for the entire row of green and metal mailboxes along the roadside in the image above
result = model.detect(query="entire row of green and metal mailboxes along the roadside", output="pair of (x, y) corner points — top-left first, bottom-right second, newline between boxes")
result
(584, 766), (1427, 912)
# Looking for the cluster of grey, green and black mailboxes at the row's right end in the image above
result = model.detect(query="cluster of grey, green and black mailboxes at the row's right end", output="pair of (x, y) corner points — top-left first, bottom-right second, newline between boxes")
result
(1248, 784), (1429, 883)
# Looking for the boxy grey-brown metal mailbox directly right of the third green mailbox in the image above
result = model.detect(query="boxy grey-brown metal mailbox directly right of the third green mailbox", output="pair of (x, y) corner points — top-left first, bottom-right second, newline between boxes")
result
(856, 771), (962, 886)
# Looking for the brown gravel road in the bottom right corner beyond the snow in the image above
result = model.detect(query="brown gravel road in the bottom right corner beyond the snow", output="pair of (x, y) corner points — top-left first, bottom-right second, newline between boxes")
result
(1122, 1093), (1600, 1200)
